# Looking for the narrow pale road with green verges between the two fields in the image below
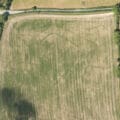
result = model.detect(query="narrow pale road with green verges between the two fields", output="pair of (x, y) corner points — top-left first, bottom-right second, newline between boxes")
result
(0, 6), (113, 14)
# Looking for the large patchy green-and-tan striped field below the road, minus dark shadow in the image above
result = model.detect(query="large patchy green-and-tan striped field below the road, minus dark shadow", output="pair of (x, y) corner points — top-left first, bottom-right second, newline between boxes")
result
(0, 15), (120, 120)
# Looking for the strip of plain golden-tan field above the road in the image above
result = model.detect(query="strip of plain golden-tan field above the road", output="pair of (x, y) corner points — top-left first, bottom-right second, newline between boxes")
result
(11, 0), (120, 9)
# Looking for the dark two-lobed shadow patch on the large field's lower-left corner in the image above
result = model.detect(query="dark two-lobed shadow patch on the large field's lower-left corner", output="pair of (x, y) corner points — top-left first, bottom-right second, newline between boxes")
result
(1, 88), (36, 120)
